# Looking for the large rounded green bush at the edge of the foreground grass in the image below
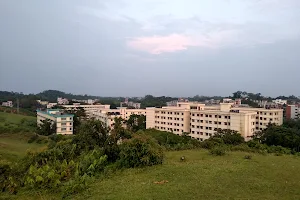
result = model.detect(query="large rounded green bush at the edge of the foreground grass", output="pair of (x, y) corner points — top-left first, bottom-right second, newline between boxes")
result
(118, 134), (164, 168)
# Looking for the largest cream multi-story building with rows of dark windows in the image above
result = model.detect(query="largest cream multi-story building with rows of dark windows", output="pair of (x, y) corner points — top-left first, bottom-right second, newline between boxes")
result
(146, 102), (283, 141)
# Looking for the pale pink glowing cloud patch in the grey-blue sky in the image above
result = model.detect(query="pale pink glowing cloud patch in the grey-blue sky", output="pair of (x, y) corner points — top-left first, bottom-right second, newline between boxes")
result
(127, 34), (203, 54)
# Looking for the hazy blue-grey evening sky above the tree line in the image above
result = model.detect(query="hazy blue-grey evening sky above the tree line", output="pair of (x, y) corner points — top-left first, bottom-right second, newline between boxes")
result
(0, 0), (300, 97)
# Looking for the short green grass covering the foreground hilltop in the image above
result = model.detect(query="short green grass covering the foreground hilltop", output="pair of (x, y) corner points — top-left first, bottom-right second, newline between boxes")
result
(7, 150), (300, 200)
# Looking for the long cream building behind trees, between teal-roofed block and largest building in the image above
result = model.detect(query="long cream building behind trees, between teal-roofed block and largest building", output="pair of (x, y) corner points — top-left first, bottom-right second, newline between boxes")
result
(90, 107), (146, 128)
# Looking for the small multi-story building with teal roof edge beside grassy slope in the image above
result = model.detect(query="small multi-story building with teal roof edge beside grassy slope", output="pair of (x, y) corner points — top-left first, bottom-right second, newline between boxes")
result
(37, 109), (74, 135)
